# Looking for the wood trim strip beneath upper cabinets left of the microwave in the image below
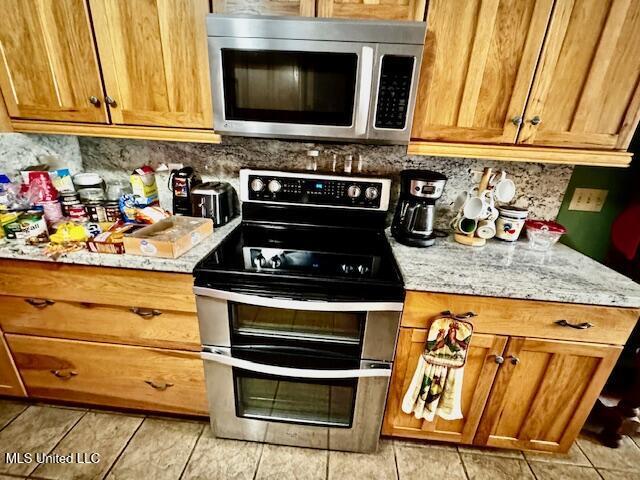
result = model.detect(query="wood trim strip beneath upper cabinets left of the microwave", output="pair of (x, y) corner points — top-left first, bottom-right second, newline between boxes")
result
(12, 120), (222, 144)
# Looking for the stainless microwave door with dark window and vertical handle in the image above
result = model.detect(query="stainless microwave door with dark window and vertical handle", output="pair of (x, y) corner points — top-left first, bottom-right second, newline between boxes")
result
(209, 37), (377, 139)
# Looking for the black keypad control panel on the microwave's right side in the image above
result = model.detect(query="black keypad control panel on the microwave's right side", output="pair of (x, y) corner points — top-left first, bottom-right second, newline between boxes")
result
(375, 55), (415, 130)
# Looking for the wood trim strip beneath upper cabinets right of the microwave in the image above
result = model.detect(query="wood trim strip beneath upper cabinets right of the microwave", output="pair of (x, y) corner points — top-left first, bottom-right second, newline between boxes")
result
(407, 141), (640, 167)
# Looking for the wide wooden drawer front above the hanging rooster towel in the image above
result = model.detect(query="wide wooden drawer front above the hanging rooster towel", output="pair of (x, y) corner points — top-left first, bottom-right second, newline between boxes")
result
(402, 292), (640, 345)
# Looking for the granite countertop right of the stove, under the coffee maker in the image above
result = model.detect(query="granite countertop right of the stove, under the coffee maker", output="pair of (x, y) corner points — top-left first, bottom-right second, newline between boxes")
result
(387, 231), (640, 308)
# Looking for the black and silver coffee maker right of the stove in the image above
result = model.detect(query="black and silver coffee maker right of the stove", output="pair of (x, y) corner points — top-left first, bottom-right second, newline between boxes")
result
(391, 170), (447, 247)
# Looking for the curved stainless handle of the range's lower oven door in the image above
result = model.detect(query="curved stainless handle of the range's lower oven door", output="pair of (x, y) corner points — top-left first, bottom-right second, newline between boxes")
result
(200, 348), (391, 378)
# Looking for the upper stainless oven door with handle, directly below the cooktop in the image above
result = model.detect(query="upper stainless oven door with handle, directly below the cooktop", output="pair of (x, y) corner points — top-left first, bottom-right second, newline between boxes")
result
(194, 287), (402, 361)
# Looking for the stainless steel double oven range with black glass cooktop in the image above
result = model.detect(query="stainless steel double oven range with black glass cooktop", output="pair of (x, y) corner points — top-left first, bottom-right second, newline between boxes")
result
(194, 170), (404, 452)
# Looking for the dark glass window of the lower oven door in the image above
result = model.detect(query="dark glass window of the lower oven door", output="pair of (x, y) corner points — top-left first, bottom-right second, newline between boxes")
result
(234, 369), (357, 428)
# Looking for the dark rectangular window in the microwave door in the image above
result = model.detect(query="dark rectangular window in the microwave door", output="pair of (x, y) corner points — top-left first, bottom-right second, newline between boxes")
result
(222, 49), (358, 126)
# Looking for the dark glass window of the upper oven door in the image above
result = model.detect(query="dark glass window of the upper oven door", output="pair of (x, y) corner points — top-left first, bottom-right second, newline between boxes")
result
(231, 303), (366, 345)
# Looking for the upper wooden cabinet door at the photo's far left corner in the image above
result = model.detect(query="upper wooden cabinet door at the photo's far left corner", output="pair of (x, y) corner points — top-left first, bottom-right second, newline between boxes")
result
(0, 0), (107, 123)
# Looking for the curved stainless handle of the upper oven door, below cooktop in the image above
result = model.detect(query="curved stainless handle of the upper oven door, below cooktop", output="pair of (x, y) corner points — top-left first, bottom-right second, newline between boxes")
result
(193, 287), (402, 312)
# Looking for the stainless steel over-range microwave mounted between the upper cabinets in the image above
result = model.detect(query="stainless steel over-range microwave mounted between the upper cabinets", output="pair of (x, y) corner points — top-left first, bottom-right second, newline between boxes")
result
(207, 15), (426, 143)
